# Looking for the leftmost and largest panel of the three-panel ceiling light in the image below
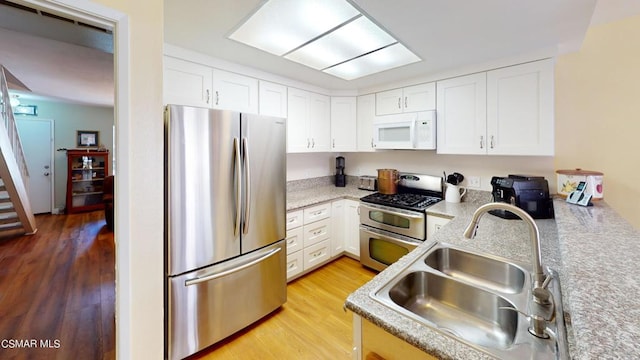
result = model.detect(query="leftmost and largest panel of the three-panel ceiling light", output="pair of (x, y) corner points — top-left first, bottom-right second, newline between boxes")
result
(229, 0), (360, 56)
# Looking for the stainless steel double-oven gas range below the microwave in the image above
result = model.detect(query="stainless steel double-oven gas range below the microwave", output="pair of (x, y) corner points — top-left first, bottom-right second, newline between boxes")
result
(360, 173), (443, 270)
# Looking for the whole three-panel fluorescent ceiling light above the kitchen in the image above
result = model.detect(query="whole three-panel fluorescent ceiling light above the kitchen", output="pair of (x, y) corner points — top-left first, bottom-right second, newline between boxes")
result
(229, 0), (421, 80)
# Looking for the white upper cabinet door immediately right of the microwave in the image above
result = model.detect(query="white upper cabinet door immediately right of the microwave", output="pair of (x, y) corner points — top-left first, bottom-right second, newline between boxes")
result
(436, 73), (487, 154)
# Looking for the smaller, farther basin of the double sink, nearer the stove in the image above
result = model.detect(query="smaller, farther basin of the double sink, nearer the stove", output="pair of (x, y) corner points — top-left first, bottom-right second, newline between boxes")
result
(425, 247), (525, 294)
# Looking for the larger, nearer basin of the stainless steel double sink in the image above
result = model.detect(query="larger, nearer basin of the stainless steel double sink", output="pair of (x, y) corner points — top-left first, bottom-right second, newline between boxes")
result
(389, 271), (518, 348)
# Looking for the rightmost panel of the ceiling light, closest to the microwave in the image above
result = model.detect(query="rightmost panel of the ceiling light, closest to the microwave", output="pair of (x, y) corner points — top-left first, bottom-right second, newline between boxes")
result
(324, 43), (420, 80)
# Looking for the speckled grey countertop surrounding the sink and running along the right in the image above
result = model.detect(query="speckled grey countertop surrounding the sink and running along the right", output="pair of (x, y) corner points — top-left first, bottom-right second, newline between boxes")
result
(345, 196), (640, 359)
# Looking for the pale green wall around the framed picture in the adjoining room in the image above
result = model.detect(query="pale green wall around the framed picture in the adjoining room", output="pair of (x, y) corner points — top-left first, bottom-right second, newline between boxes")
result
(16, 100), (114, 209)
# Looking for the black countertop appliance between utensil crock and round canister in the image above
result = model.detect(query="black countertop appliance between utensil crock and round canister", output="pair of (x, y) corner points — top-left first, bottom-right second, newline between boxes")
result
(489, 175), (554, 219)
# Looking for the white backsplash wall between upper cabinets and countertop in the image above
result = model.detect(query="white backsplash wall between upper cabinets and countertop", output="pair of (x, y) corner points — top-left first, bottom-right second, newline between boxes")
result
(287, 150), (556, 193)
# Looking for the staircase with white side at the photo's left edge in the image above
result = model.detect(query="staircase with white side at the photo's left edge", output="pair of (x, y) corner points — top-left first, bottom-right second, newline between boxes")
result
(0, 65), (38, 238)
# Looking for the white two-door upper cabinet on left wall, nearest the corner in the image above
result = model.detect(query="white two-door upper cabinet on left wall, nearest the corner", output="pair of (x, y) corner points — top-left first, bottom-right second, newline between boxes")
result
(287, 88), (331, 153)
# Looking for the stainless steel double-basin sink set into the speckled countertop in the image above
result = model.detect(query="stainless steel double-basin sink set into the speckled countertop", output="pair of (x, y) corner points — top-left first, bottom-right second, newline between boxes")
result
(370, 243), (568, 359)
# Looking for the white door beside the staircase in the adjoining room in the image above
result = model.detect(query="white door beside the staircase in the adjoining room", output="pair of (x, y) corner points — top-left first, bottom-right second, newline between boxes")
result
(16, 119), (53, 214)
